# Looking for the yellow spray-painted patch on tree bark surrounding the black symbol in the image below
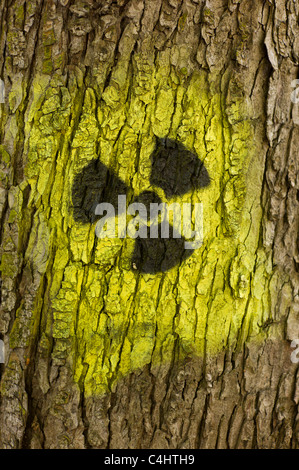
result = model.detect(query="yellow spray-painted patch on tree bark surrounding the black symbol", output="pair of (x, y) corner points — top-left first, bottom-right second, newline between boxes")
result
(2, 55), (274, 395)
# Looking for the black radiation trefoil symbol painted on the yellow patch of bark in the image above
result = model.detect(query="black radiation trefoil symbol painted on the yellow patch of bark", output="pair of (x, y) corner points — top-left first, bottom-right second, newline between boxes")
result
(72, 138), (210, 274)
